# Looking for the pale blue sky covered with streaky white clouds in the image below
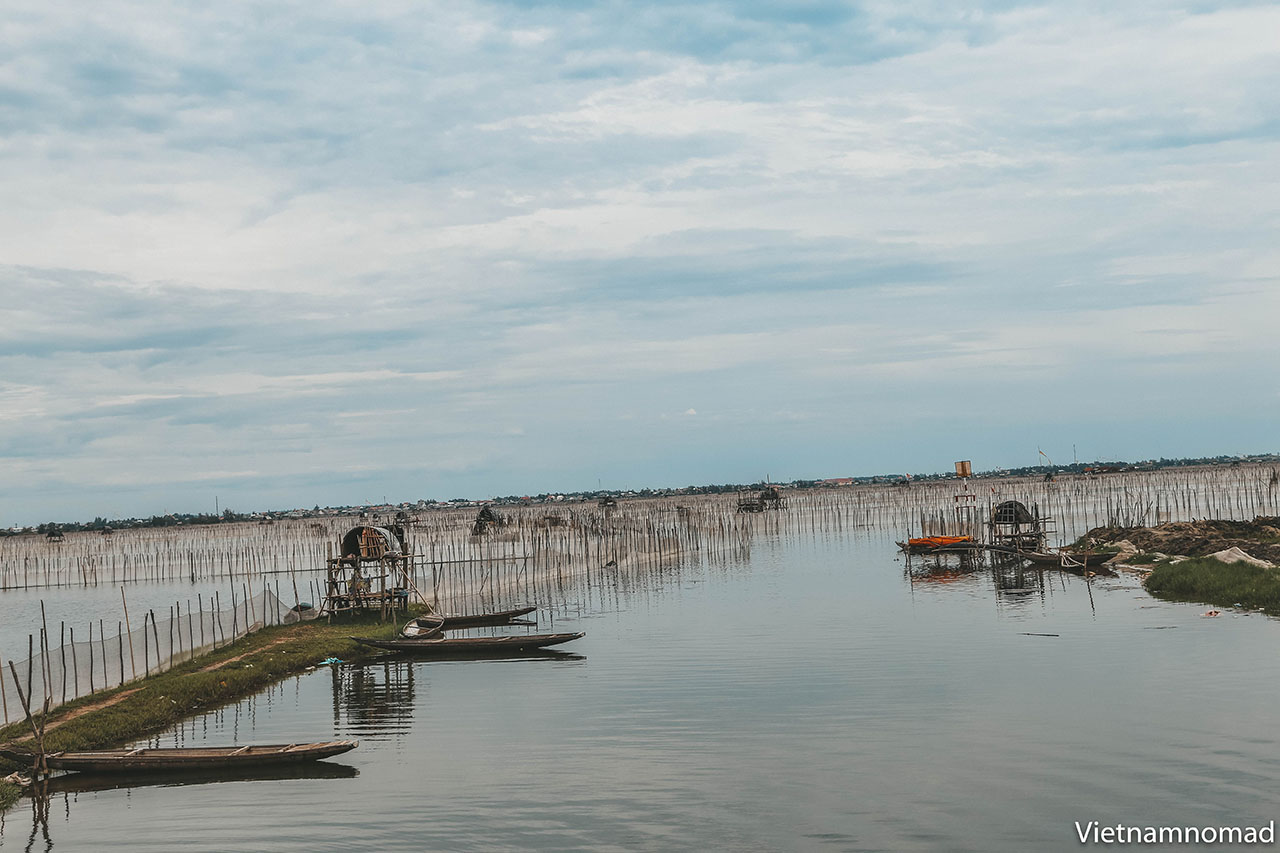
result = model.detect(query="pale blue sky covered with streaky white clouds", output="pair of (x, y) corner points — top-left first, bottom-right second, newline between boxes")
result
(0, 0), (1280, 526)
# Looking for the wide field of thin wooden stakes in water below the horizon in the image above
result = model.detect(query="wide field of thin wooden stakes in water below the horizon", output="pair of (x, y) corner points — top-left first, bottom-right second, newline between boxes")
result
(0, 465), (1280, 594)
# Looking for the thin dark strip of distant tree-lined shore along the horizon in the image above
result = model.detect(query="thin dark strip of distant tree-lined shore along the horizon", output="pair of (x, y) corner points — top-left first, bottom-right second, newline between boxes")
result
(0, 453), (1280, 537)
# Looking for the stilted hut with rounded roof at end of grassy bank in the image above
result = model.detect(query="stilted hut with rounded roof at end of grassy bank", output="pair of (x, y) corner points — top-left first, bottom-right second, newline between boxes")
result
(321, 525), (416, 615)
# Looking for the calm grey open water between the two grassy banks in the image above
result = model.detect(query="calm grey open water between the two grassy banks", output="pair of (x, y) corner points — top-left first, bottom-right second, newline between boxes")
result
(0, 527), (1280, 853)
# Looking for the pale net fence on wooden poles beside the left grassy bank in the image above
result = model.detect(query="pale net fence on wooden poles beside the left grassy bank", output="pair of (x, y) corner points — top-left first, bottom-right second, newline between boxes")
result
(0, 589), (317, 724)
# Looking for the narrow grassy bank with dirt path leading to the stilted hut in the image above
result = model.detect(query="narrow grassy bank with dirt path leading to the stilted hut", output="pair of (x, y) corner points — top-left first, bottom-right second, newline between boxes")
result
(0, 607), (412, 770)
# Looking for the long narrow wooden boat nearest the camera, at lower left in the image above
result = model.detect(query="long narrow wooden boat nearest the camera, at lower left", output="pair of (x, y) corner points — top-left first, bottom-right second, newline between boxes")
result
(0, 740), (358, 774)
